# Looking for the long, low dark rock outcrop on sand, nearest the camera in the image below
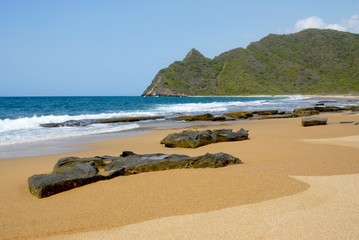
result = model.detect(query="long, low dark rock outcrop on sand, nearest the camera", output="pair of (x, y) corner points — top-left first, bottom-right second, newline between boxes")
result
(28, 151), (242, 198)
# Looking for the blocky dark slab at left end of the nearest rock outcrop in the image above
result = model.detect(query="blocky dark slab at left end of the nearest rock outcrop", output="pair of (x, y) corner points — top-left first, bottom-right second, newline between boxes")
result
(28, 162), (102, 198)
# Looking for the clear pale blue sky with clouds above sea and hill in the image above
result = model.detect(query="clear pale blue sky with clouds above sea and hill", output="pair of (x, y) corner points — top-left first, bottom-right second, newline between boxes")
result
(0, 0), (359, 96)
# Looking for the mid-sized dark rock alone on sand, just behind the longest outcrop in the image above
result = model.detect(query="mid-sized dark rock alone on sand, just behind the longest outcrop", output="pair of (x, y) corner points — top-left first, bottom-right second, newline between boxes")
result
(161, 129), (248, 148)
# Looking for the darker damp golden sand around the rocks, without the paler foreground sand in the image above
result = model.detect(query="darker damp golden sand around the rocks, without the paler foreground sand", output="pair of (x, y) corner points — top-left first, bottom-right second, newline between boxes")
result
(0, 113), (359, 239)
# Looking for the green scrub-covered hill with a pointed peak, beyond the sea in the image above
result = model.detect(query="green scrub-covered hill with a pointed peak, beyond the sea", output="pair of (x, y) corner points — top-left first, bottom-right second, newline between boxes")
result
(142, 29), (359, 96)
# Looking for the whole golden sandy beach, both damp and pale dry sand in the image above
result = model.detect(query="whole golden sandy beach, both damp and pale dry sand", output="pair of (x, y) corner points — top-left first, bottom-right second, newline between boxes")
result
(0, 113), (359, 240)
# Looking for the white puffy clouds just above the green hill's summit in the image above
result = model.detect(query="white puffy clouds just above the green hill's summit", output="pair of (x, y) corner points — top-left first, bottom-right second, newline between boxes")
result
(294, 15), (359, 33)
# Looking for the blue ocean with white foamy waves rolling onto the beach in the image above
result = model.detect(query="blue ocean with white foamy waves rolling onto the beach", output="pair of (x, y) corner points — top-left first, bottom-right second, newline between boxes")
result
(0, 96), (358, 158)
